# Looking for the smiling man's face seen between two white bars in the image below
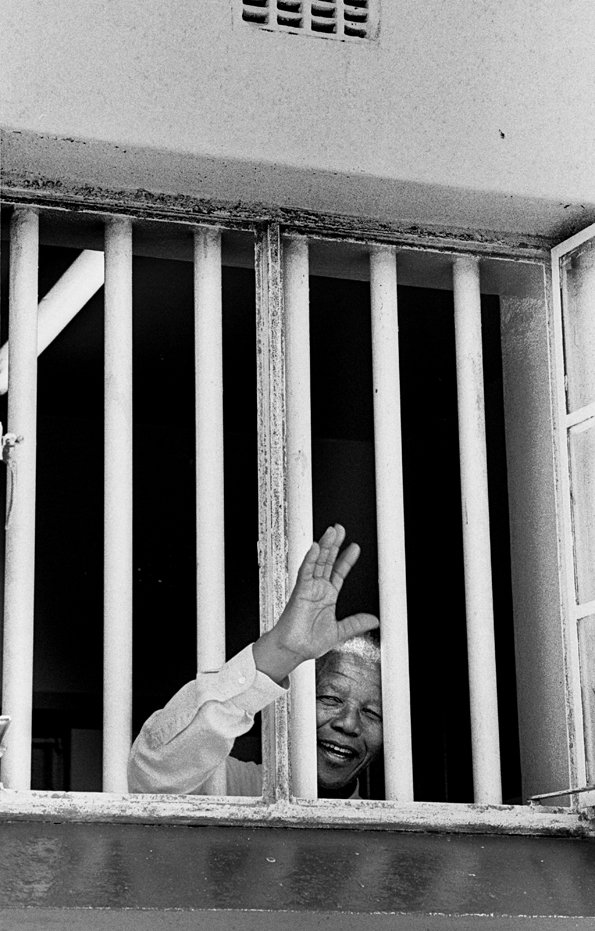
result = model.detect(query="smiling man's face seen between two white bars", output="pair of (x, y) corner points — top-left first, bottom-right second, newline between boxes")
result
(316, 653), (382, 791)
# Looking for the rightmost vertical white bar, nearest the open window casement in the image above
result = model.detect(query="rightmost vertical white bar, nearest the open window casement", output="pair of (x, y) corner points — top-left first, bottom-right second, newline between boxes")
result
(453, 256), (502, 805)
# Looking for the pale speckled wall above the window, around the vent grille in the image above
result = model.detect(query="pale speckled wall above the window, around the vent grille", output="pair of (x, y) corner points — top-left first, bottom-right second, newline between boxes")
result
(0, 0), (595, 206)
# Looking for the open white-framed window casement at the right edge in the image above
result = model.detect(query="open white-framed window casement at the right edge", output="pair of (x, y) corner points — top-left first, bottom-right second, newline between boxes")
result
(552, 226), (595, 808)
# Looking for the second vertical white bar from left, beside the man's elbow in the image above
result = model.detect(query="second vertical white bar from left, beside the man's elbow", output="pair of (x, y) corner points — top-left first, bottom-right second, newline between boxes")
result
(103, 217), (132, 792)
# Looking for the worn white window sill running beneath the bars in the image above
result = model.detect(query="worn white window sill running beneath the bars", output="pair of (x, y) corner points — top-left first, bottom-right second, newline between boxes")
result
(0, 789), (595, 837)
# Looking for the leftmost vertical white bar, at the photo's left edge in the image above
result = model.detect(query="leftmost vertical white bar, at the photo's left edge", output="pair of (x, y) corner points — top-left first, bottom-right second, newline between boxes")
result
(2, 209), (39, 789)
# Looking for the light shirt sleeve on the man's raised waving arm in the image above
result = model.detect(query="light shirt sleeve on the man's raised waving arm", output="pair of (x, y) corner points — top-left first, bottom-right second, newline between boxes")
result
(128, 645), (285, 795)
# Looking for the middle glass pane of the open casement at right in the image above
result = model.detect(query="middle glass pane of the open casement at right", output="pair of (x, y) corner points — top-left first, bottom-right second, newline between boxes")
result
(569, 421), (595, 603)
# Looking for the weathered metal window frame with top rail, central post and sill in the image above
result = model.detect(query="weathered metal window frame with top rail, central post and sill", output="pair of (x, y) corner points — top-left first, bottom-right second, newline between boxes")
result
(0, 190), (595, 836)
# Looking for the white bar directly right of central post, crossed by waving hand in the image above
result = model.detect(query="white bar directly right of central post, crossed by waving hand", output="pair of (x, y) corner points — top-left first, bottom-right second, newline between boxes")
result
(283, 237), (317, 798)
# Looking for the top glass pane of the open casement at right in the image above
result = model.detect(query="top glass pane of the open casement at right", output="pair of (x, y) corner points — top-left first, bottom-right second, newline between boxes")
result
(560, 240), (595, 411)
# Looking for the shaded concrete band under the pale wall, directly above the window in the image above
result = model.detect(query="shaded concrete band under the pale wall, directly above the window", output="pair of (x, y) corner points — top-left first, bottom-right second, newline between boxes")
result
(1, 129), (595, 244)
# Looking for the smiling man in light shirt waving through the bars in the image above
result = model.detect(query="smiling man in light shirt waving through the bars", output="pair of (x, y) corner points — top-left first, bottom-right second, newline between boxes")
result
(128, 524), (382, 798)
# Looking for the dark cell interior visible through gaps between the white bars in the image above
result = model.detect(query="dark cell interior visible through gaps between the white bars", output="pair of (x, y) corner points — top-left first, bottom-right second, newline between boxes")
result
(0, 238), (520, 801)
